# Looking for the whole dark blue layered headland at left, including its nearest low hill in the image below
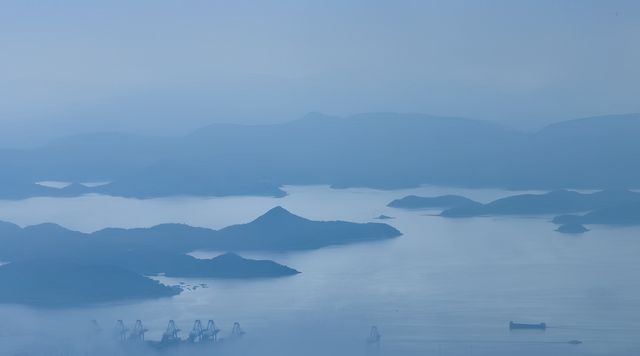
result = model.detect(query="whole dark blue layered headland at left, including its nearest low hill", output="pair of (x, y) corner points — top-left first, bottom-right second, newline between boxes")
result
(0, 207), (400, 305)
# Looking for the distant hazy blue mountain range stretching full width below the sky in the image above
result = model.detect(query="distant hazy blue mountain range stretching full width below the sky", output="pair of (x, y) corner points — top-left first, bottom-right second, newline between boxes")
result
(0, 113), (640, 199)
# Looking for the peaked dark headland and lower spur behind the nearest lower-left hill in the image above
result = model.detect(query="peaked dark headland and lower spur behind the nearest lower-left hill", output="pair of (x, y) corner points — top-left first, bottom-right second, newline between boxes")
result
(0, 207), (400, 278)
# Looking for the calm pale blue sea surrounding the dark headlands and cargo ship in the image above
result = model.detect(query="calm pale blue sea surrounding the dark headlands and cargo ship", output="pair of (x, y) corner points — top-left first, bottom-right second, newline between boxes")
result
(0, 186), (640, 355)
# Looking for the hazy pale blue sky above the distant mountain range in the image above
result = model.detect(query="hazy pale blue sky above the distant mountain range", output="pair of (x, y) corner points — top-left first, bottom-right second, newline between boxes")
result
(0, 0), (640, 143)
